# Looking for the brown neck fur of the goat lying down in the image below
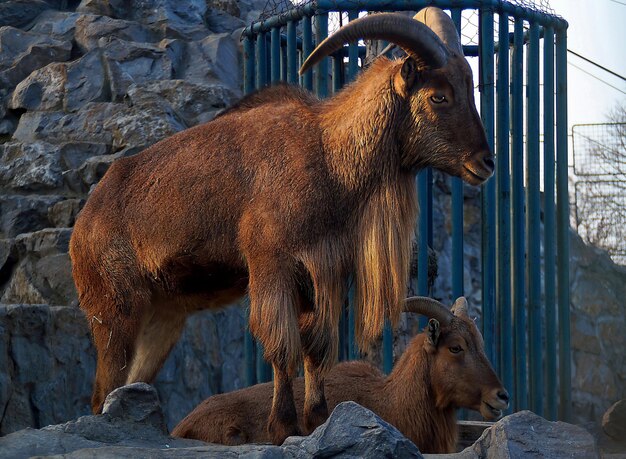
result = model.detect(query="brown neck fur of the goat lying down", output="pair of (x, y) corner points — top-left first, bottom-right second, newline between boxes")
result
(385, 334), (457, 453)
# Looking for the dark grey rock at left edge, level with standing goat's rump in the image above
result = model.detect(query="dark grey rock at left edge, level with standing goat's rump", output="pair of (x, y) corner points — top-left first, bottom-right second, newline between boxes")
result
(0, 195), (63, 238)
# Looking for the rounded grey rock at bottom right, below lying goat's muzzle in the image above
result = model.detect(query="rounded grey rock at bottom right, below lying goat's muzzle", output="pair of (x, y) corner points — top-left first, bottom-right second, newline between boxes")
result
(424, 411), (599, 459)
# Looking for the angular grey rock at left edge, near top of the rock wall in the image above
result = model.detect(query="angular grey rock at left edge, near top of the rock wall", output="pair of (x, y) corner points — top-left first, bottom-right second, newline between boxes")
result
(0, 26), (72, 88)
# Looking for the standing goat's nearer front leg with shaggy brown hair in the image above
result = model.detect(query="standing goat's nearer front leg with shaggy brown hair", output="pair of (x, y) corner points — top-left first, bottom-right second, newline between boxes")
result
(248, 258), (302, 445)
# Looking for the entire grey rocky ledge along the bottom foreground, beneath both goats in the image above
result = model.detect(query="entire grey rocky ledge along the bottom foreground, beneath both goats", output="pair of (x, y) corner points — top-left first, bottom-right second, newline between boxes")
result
(0, 383), (598, 459)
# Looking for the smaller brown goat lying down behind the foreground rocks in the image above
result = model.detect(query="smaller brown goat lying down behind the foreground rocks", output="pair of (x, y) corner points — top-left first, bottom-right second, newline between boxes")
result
(172, 297), (509, 453)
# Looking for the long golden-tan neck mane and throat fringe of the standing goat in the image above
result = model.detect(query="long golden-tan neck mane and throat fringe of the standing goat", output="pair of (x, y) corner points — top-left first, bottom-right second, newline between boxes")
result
(321, 59), (417, 349)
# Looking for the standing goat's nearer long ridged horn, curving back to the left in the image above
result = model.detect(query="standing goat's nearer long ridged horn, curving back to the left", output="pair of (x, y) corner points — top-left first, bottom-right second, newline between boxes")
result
(300, 13), (448, 75)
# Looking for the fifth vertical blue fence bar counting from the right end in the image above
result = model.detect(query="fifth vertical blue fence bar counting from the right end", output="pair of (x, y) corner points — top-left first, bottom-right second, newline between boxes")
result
(496, 9), (513, 406)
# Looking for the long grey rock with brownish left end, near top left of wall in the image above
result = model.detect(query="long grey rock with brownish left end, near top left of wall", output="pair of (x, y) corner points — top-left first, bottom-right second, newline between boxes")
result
(74, 14), (163, 52)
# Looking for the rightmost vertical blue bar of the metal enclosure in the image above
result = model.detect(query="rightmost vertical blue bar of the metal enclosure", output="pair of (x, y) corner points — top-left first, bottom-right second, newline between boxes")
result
(556, 29), (572, 421)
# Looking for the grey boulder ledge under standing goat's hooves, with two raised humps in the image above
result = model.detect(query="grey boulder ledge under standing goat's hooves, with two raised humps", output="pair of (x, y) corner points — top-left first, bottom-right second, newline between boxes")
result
(0, 394), (422, 459)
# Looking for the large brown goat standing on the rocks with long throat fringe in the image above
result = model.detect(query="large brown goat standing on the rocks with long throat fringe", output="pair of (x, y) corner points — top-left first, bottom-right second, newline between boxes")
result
(70, 9), (494, 444)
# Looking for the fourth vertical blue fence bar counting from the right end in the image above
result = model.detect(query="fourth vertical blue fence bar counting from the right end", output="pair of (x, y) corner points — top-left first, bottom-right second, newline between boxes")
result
(511, 19), (528, 411)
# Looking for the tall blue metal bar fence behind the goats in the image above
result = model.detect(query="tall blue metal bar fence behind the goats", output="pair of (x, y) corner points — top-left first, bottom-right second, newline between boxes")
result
(243, 0), (571, 419)
